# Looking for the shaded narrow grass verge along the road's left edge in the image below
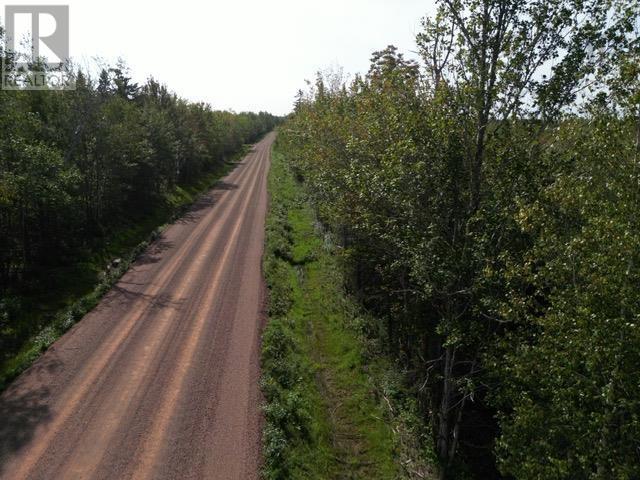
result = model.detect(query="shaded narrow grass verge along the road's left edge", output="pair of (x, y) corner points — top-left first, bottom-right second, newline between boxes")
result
(0, 147), (248, 391)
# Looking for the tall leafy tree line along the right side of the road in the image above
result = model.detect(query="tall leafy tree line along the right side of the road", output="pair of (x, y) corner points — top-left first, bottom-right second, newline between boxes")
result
(278, 0), (640, 479)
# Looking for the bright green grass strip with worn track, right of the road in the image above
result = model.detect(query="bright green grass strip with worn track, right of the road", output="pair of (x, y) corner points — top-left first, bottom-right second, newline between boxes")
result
(262, 145), (431, 479)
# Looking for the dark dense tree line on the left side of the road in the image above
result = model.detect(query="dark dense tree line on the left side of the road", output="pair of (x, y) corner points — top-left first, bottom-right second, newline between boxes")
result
(0, 58), (276, 287)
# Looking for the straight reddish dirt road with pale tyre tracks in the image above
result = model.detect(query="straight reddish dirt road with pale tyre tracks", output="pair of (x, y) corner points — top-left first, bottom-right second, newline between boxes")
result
(0, 134), (274, 480)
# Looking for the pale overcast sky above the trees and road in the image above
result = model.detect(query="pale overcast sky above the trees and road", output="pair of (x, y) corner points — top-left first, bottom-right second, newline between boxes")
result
(2, 0), (435, 115)
